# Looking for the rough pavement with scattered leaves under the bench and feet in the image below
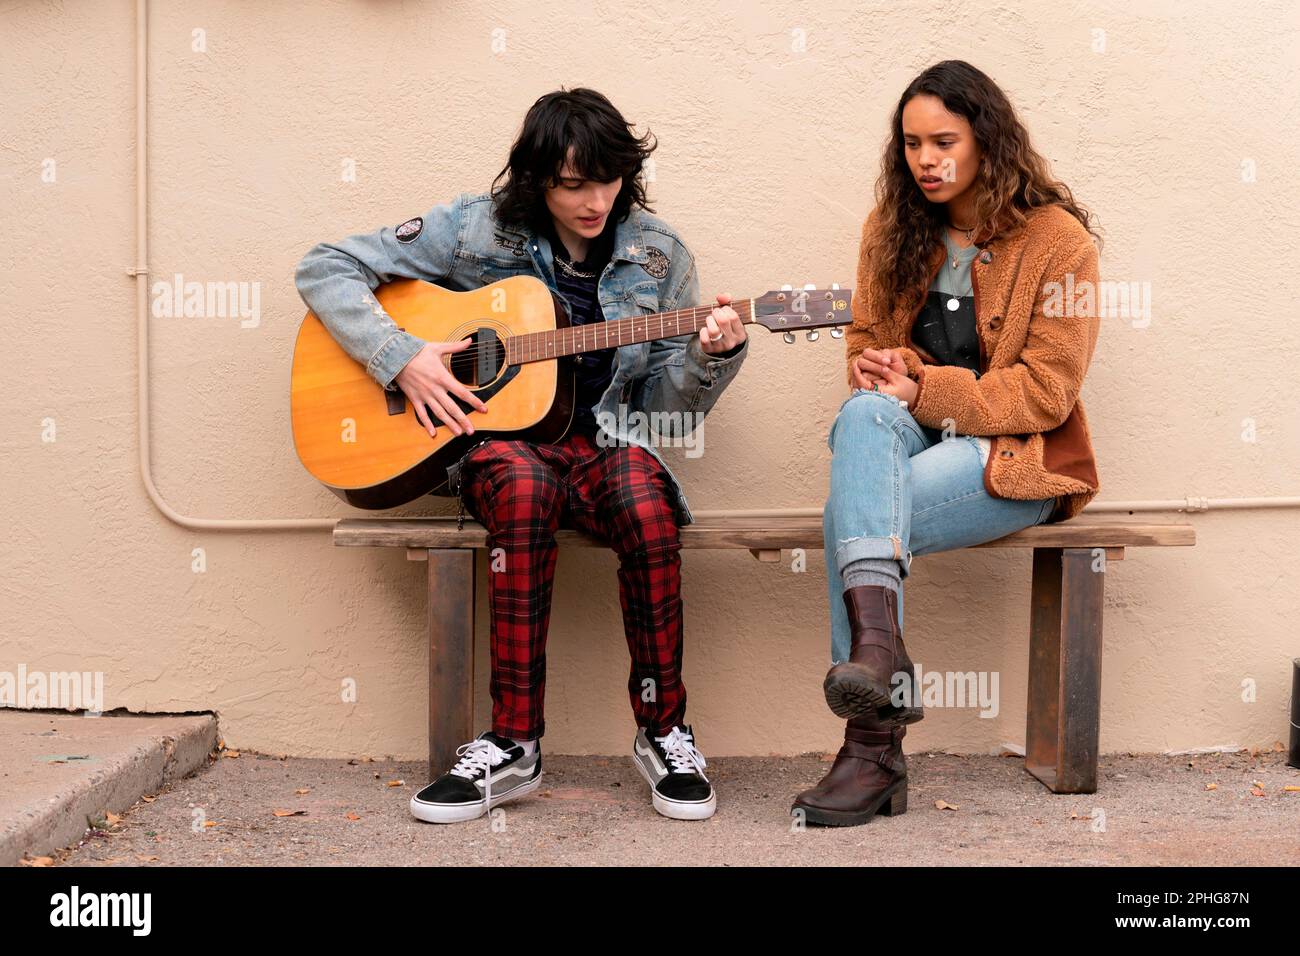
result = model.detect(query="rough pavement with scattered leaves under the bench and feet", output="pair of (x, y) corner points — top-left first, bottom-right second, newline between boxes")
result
(15, 728), (1300, 866)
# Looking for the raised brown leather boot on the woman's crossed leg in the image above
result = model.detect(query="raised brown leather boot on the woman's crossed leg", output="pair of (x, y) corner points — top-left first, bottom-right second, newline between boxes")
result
(823, 584), (926, 723)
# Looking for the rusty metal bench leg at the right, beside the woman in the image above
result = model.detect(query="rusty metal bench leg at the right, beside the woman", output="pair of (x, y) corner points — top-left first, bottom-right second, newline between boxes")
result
(1024, 548), (1106, 793)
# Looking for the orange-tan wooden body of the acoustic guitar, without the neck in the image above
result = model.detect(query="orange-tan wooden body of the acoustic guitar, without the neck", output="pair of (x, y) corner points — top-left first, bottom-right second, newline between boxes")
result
(290, 276), (573, 510)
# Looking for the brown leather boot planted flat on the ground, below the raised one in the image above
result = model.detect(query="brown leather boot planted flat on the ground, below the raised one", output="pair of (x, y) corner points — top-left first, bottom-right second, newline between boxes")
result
(790, 717), (907, 826)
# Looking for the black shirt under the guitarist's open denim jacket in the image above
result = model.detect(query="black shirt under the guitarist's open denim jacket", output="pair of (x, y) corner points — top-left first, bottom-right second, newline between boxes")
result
(546, 216), (616, 434)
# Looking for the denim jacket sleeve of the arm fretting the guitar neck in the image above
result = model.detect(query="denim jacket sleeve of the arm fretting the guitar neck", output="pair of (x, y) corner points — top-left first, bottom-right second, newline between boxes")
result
(637, 254), (749, 414)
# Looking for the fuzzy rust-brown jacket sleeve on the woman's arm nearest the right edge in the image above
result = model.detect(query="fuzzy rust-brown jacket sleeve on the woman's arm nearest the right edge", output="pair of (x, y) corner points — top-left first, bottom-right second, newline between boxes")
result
(911, 230), (1100, 436)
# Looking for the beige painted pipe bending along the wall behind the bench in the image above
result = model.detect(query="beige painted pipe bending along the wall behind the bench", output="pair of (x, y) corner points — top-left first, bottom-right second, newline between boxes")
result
(127, 0), (1300, 531)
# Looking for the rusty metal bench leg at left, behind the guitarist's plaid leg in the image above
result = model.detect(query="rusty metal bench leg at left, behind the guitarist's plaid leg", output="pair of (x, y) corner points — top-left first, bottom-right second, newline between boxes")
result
(429, 548), (475, 779)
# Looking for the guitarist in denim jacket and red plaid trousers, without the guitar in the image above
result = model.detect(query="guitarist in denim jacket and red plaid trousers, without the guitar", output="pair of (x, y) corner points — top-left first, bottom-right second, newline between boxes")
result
(295, 88), (753, 823)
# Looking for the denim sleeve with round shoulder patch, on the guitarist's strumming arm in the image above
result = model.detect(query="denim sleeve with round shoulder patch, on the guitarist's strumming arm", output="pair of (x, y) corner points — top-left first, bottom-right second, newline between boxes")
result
(294, 198), (462, 388)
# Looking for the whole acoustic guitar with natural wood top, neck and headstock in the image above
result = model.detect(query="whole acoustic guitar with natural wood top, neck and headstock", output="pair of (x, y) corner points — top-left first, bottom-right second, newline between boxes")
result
(290, 276), (852, 509)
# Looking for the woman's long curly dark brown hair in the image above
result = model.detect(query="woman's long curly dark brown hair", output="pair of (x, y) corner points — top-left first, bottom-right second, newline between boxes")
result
(866, 60), (1101, 320)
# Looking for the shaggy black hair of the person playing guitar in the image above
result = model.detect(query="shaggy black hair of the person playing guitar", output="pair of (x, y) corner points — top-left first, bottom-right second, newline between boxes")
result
(491, 87), (658, 230)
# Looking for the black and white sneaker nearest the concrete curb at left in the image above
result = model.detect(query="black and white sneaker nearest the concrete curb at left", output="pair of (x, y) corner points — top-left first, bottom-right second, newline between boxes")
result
(411, 731), (542, 823)
